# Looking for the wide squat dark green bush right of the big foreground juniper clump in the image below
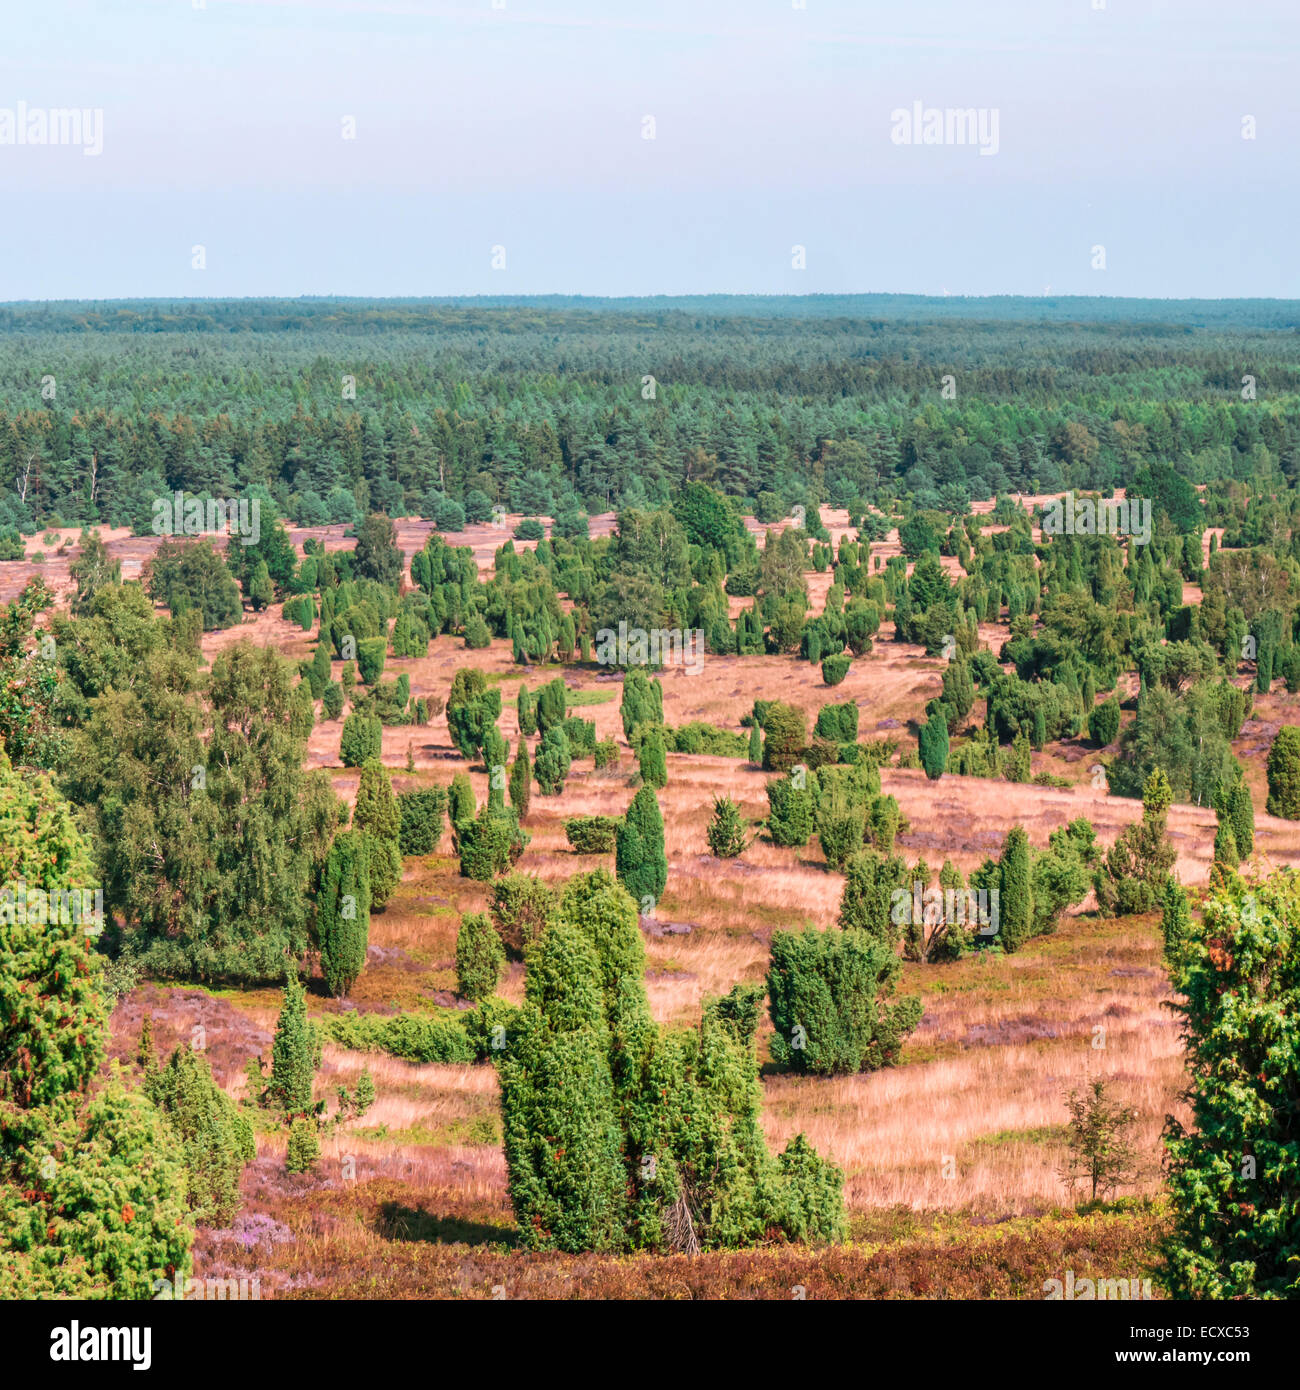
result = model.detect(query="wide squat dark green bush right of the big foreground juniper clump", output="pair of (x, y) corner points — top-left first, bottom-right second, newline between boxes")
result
(767, 927), (922, 1076)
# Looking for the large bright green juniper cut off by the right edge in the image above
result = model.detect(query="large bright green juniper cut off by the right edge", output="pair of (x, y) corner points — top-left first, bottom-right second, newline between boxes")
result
(1164, 869), (1300, 1300)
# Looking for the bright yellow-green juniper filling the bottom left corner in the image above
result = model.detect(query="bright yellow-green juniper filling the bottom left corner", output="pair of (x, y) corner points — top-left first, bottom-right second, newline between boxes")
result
(0, 745), (193, 1300)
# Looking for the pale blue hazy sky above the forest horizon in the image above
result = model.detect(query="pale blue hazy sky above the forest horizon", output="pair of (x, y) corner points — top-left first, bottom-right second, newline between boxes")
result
(0, 0), (1300, 300)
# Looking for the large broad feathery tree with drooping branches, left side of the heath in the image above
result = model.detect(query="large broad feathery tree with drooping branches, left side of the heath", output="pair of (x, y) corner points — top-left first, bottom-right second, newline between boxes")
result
(67, 642), (339, 981)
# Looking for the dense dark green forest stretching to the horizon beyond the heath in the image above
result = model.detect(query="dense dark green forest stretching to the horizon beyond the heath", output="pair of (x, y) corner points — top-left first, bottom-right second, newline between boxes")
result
(0, 295), (1300, 534)
